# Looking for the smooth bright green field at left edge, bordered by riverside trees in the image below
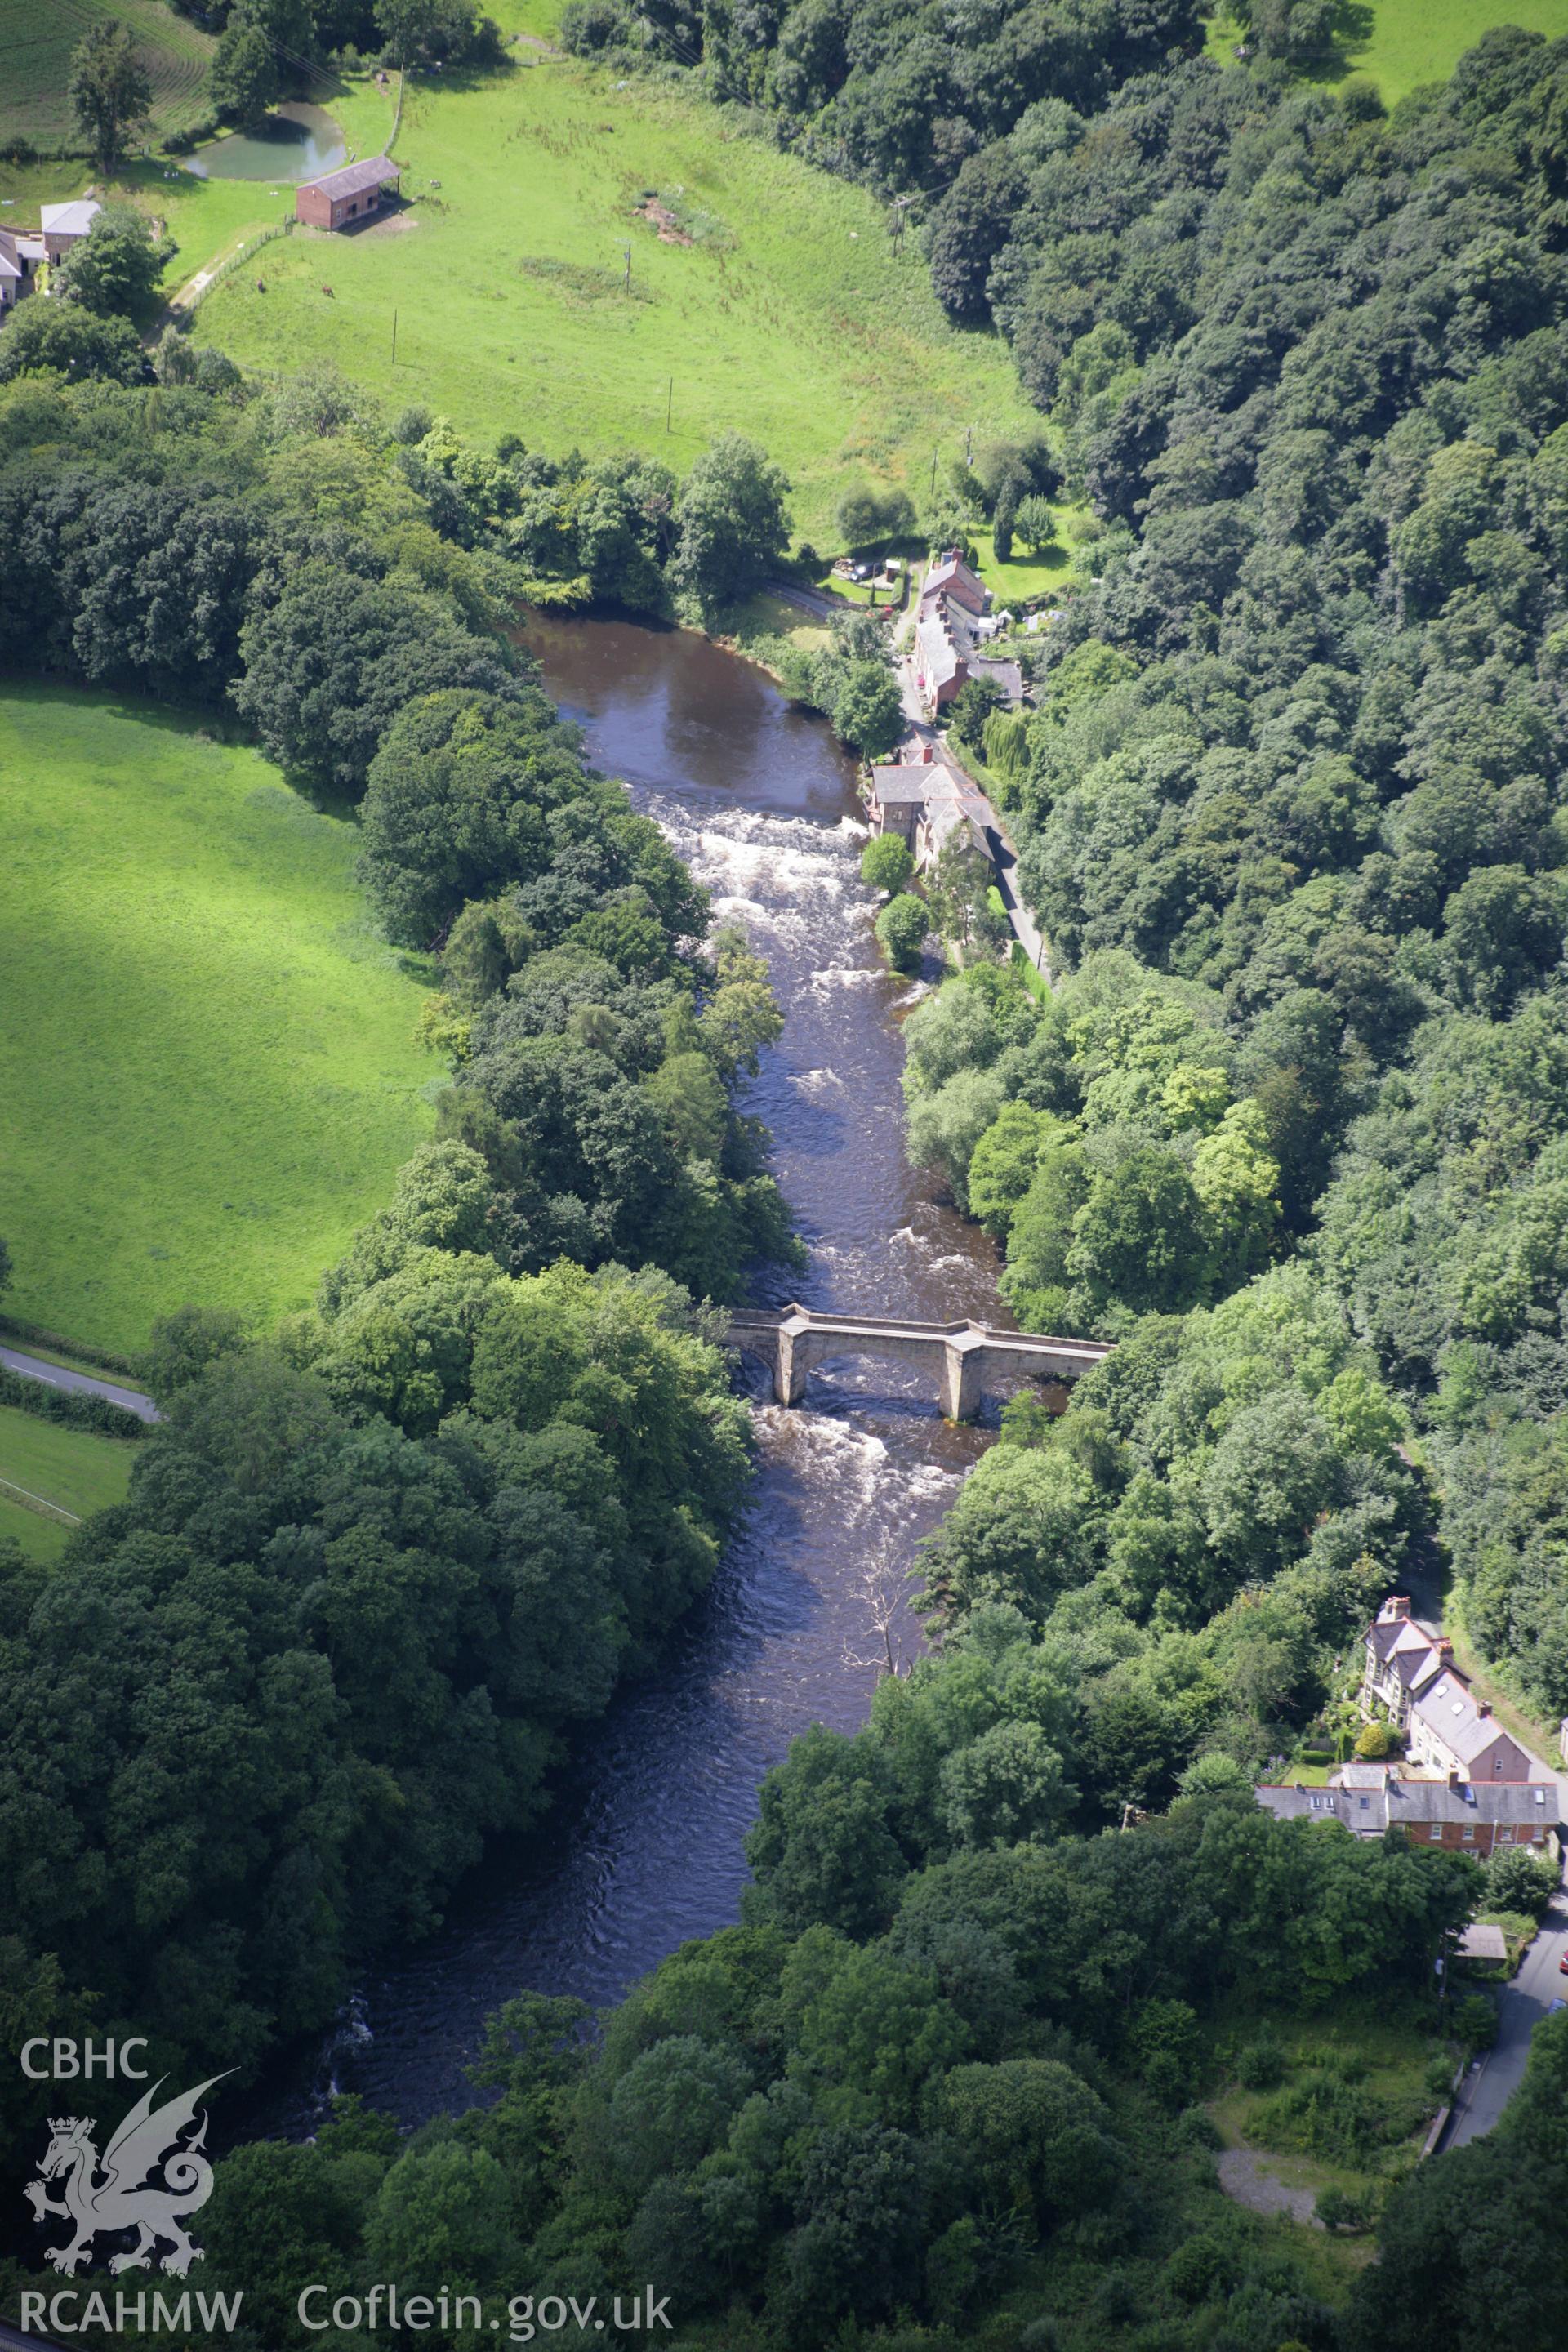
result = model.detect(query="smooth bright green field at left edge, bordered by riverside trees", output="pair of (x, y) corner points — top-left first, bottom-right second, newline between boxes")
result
(0, 684), (439, 1350)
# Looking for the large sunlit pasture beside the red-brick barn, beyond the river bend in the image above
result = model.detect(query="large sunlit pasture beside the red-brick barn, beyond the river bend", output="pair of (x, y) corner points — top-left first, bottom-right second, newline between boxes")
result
(190, 47), (1039, 546)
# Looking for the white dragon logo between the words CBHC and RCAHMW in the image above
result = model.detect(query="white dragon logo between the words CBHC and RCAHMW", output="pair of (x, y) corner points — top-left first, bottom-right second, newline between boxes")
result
(24, 2068), (233, 2279)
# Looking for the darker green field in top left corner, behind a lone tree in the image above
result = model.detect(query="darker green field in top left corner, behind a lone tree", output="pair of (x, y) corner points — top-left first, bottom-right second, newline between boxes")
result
(0, 0), (216, 150)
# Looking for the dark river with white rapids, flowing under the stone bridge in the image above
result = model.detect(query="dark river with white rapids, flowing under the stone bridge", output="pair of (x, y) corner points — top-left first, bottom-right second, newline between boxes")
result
(263, 618), (1001, 2131)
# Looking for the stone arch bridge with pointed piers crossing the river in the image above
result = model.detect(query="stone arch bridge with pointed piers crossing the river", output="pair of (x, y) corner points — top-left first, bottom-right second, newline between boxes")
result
(728, 1305), (1110, 1421)
